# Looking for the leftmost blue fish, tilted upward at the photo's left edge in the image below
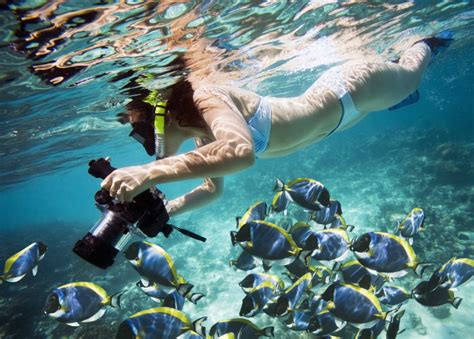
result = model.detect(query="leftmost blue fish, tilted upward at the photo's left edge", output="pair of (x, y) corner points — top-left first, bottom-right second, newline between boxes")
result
(0, 241), (48, 284)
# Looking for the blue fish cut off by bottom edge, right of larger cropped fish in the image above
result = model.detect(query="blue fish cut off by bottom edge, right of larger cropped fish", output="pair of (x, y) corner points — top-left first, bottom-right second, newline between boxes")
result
(209, 318), (274, 339)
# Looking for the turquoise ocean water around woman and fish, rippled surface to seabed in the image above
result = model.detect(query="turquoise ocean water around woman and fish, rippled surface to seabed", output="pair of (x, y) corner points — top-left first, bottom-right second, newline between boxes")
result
(0, 1), (474, 338)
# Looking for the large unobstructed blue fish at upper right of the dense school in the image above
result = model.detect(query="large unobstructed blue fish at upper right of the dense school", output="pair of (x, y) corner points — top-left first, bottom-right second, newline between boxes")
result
(351, 232), (428, 277)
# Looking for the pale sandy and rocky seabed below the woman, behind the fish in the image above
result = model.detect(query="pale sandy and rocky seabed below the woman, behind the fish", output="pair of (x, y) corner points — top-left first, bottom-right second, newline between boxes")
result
(0, 129), (474, 338)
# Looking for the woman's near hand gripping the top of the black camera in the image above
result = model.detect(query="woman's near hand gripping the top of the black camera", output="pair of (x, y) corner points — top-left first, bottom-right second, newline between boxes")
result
(101, 166), (153, 202)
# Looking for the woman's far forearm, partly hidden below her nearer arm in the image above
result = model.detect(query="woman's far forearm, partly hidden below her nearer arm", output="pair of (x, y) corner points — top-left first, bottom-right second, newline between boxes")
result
(166, 178), (224, 216)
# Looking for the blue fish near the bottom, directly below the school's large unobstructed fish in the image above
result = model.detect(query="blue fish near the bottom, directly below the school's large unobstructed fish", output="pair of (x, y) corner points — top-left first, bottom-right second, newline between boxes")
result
(321, 283), (387, 328)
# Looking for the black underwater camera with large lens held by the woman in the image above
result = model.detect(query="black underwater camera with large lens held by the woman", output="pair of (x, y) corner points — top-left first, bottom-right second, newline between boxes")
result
(73, 158), (206, 269)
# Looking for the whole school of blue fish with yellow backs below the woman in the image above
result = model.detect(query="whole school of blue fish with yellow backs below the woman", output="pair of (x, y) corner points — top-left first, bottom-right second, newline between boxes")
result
(0, 178), (474, 339)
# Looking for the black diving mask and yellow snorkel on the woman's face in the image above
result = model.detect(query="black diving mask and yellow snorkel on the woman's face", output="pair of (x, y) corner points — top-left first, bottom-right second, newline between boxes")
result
(129, 91), (167, 160)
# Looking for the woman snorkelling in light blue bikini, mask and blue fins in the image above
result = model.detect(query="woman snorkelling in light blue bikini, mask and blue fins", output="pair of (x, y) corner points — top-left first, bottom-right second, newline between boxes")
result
(102, 34), (453, 215)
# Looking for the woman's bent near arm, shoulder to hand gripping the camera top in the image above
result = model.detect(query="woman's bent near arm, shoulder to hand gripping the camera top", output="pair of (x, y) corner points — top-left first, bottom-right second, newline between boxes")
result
(102, 90), (255, 201)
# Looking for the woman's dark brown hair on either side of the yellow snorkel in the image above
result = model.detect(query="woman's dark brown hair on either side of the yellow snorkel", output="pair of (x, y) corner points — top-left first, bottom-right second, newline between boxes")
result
(117, 56), (206, 127)
